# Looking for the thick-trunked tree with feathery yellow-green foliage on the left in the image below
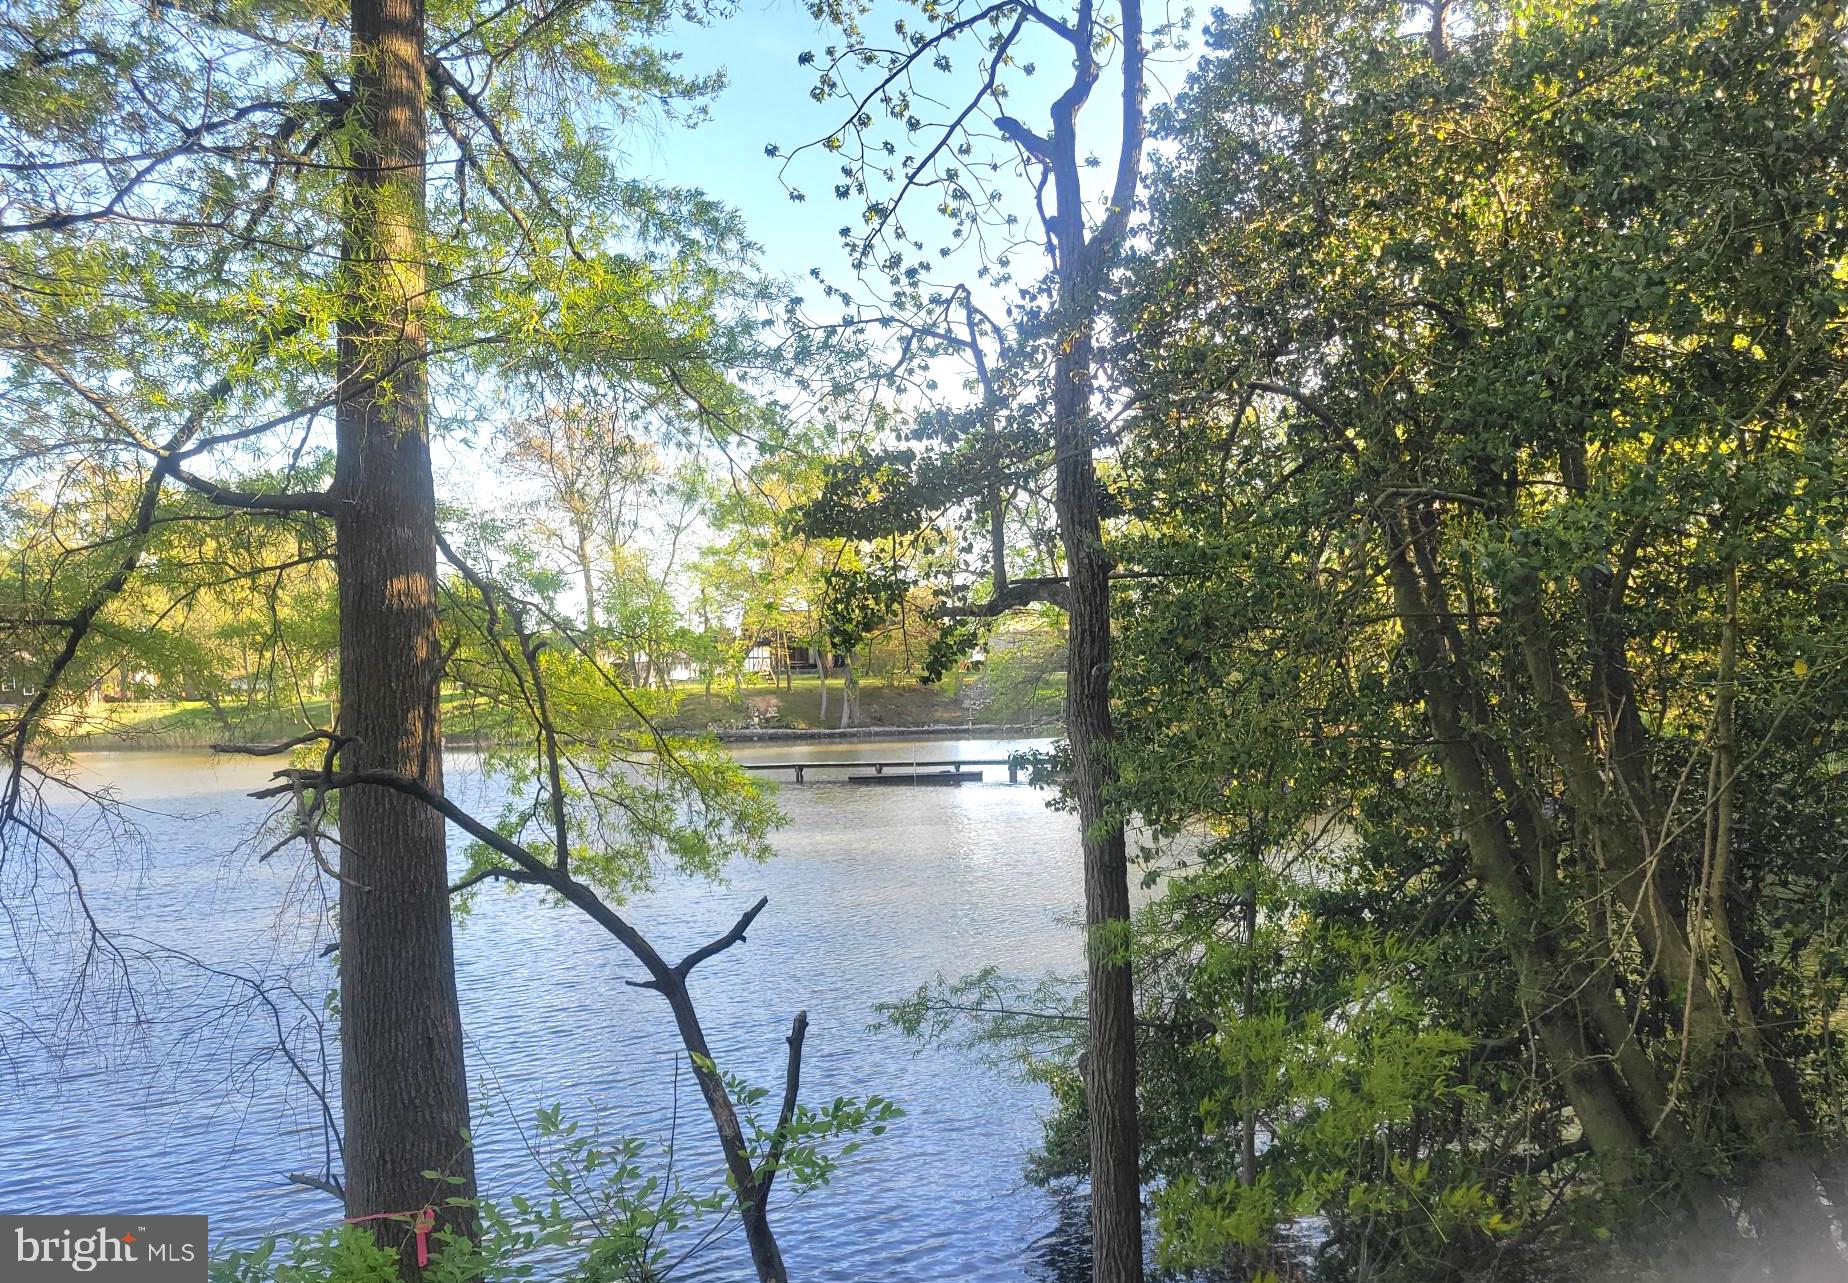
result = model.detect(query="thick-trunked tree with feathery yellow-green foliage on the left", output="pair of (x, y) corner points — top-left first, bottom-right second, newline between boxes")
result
(0, 0), (802, 1274)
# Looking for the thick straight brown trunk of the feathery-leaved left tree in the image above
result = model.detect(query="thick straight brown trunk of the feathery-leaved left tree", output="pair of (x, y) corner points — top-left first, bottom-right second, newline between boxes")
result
(333, 0), (475, 1277)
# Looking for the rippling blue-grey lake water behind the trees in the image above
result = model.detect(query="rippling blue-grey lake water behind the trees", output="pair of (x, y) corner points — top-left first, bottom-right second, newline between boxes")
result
(0, 739), (1088, 1283)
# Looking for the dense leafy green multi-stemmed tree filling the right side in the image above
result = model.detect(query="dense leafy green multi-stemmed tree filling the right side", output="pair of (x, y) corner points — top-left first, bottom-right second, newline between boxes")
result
(1086, 0), (1844, 1277)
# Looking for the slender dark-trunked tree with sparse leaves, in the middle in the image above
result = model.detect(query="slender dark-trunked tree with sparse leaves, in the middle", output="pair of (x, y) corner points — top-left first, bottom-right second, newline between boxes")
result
(790, 0), (1164, 1283)
